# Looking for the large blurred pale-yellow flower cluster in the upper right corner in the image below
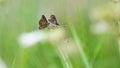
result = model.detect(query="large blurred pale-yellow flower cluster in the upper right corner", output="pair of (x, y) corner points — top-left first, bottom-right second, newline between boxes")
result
(91, 2), (120, 23)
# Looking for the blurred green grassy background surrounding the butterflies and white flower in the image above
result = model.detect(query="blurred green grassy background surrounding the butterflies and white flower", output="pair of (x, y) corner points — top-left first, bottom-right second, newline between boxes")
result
(0, 0), (120, 68)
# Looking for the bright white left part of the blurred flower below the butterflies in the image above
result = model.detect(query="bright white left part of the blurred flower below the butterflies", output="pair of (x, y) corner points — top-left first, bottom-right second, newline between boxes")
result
(19, 31), (46, 47)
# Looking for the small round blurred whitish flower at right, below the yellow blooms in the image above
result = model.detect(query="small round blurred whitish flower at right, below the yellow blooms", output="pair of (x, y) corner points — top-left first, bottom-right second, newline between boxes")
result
(91, 21), (108, 34)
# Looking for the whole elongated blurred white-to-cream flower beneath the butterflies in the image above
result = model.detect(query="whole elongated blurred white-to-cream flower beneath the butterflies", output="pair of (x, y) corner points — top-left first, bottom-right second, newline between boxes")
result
(19, 28), (65, 48)
